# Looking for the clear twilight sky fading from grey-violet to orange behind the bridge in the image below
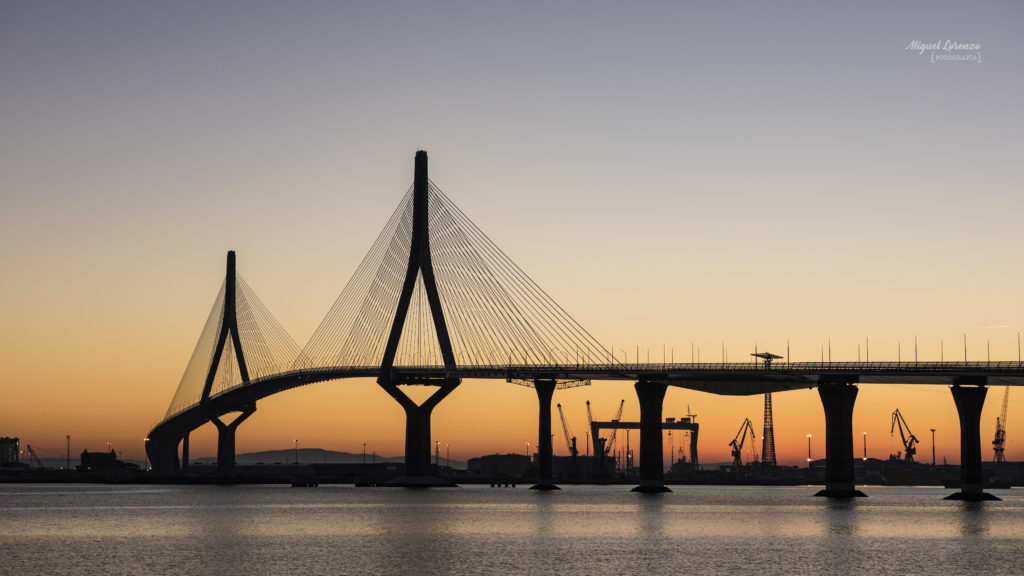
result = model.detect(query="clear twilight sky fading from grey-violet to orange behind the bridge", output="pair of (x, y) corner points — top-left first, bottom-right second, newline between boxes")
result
(0, 0), (1024, 463)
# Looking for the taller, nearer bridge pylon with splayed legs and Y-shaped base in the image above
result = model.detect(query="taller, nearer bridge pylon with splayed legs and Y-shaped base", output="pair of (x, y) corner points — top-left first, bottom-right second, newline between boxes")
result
(377, 150), (461, 486)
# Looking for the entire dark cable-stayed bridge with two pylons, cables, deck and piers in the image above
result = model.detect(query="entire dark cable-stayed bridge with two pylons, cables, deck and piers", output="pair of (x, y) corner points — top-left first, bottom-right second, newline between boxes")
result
(146, 151), (1024, 499)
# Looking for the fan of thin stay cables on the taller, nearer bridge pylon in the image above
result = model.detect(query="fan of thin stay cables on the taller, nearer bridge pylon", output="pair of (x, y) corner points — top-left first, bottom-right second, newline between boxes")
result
(296, 182), (613, 368)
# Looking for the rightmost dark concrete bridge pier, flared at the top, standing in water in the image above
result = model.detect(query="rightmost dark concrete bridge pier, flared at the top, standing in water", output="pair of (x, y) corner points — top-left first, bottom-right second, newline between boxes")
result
(946, 377), (999, 500)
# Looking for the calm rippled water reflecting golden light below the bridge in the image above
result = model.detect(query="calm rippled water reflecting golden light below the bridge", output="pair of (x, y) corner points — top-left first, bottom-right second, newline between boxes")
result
(0, 485), (1024, 576)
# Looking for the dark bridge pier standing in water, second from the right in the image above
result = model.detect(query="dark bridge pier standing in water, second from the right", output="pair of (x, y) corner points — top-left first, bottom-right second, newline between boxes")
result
(808, 381), (866, 498)
